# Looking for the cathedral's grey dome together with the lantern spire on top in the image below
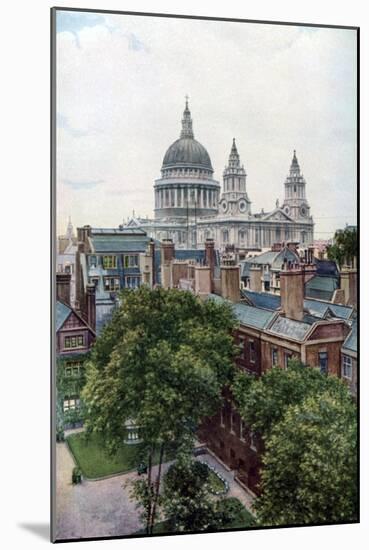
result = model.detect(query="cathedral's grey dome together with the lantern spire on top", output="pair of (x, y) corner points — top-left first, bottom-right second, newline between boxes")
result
(161, 99), (213, 172)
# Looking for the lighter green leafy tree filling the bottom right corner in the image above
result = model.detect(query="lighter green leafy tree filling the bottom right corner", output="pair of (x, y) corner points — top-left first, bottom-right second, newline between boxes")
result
(255, 392), (357, 525)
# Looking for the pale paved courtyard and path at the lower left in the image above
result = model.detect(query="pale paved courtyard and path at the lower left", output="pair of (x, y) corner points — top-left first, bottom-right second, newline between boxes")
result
(56, 434), (252, 540)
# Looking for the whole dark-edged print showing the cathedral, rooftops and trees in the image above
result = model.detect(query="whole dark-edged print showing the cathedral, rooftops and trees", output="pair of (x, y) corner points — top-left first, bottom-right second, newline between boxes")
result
(51, 8), (359, 542)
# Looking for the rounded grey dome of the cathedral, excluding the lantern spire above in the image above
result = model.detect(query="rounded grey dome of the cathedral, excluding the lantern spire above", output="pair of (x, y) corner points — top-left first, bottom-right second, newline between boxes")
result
(162, 137), (213, 170)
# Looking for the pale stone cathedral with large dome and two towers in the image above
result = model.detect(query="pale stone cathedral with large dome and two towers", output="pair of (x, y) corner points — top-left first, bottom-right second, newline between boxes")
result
(122, 101), (314, 252)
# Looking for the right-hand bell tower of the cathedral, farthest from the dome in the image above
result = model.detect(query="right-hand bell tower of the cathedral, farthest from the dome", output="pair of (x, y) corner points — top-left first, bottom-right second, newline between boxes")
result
(282, 150), (310, 220)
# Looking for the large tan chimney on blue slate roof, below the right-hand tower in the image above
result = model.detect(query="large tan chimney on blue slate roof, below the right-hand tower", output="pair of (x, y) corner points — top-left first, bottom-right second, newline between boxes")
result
(280, 264), (305, 321)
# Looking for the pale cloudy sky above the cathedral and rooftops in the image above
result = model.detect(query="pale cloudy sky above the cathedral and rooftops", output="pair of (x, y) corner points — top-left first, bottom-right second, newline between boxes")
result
(56, 11), (357, 239)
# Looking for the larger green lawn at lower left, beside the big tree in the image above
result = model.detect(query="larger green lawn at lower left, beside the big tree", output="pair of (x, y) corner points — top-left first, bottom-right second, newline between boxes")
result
(67, 432), (154, 478)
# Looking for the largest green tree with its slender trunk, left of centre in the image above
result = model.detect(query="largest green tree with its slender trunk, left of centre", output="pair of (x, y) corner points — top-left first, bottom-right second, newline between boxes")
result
(83, 286), (236, 533)
